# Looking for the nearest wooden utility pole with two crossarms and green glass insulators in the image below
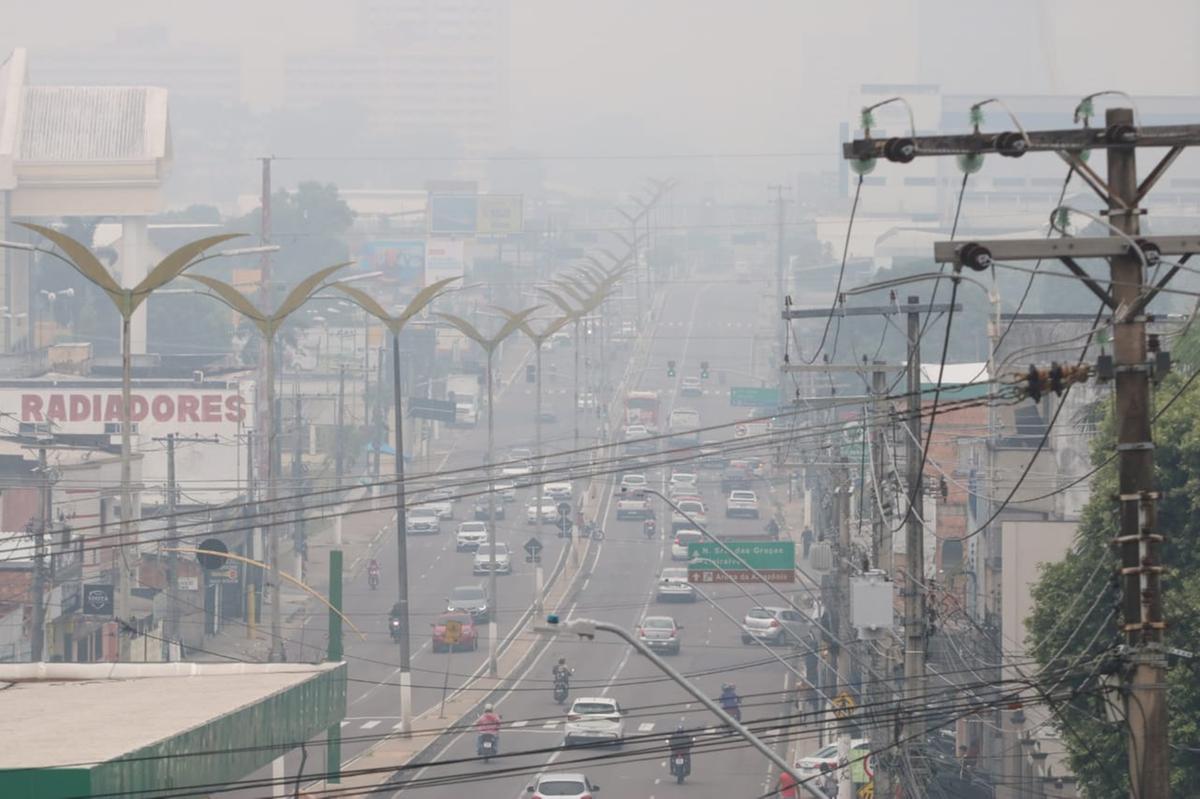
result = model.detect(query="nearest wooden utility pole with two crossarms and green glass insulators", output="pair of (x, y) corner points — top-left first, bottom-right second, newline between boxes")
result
(842, 107), (1200, 799)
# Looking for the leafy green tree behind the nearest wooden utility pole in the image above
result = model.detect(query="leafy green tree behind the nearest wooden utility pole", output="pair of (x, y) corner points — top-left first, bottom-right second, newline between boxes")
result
(1026, 332), (1200, 799)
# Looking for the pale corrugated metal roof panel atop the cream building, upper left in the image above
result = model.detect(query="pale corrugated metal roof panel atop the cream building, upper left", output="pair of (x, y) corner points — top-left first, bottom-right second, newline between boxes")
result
(17, 86), (166, 162)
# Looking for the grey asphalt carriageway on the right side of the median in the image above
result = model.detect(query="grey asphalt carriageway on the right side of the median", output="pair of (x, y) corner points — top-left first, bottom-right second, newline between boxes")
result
(388, 275), (806, 799)
